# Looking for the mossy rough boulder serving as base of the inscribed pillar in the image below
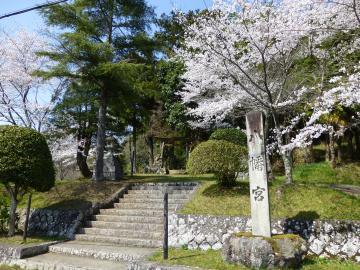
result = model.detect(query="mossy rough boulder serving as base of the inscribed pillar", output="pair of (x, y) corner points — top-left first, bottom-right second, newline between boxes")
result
(222, 233), (307, 269)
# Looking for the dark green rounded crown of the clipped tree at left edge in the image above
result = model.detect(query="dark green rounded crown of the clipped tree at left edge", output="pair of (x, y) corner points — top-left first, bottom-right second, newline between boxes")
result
(0, 126), (55, 191)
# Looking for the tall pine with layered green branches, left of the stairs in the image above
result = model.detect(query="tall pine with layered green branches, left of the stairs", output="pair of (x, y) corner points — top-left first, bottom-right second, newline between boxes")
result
(40, 0), (154, 181)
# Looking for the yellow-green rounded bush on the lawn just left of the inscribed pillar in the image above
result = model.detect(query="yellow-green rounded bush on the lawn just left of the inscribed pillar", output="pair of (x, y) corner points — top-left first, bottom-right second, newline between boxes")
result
(187, 140), (247, 186)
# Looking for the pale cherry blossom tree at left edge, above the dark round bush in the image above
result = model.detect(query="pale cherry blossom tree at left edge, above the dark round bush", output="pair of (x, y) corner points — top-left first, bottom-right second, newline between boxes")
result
(0, 30), (62, 131)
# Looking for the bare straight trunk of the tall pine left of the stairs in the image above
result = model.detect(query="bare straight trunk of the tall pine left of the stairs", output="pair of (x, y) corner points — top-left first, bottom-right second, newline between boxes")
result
(94, 90), (107, 182)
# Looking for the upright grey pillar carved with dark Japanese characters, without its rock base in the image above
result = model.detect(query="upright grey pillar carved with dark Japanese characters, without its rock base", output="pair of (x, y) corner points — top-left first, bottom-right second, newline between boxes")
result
(246, 112), (271, 237)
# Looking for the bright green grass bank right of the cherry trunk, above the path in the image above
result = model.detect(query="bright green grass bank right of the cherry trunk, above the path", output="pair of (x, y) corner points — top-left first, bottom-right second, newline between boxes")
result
(292, 162), (360, 186)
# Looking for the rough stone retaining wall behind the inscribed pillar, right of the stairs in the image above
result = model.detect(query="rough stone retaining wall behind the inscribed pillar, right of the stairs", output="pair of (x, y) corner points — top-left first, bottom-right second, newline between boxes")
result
(169, 214), (360, 262)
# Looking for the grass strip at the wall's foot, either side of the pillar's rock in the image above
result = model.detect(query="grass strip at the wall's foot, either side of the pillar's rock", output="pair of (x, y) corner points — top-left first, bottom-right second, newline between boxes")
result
(150, 248), (359, 270)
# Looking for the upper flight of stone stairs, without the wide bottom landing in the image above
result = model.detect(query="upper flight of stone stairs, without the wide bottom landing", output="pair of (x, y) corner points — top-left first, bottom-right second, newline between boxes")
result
(75, 183), (196, 248)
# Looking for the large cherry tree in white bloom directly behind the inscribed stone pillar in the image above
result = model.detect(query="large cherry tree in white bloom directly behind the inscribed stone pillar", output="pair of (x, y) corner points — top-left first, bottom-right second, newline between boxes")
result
(177, 0), (358, 183)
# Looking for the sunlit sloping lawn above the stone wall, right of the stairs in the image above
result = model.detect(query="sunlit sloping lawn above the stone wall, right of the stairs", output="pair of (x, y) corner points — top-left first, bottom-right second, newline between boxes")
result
(182, 162), (360, 220)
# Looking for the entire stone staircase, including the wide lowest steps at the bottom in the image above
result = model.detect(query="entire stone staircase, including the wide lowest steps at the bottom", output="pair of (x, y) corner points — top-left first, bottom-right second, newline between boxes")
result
(17, 183), (197, 270)
